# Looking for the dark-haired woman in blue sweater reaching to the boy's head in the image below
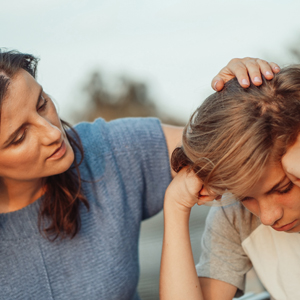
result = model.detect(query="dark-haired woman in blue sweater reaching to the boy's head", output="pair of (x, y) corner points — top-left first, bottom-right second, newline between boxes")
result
(0, 51), (276, 300)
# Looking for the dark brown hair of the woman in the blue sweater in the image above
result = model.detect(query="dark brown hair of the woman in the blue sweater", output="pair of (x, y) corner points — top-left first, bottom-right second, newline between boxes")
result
(0, 49), (89, 240)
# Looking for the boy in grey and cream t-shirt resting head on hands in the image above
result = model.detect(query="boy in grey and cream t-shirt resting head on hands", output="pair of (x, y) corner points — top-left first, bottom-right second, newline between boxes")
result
(160, 65), (300, 300)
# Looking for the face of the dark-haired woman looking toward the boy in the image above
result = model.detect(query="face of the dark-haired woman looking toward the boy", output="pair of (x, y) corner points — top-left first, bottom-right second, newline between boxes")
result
(0, 70), (74, 181)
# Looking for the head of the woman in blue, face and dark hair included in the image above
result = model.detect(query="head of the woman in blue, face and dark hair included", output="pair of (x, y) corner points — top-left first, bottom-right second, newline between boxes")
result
(0, 49), (88, 238)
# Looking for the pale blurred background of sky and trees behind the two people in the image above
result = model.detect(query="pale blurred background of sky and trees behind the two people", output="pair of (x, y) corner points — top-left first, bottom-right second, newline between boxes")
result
(0, 0), (300, 300)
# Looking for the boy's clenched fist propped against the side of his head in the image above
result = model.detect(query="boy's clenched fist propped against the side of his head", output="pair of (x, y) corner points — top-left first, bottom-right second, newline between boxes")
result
(165, 168), (215, 210)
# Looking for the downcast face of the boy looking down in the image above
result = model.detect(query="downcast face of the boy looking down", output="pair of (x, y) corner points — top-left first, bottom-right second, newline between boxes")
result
(241, 163), (300, 232)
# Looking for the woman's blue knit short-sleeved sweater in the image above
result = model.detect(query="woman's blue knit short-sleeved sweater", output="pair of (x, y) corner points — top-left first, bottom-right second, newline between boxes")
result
(0, 118), (171, 300)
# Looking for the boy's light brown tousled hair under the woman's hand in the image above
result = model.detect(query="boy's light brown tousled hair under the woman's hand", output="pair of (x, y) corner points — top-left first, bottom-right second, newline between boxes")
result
(172, 65), (300, 197)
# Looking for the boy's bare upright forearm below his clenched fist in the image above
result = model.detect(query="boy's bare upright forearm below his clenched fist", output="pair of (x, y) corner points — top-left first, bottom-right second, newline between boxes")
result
(160, 197), (203, 300)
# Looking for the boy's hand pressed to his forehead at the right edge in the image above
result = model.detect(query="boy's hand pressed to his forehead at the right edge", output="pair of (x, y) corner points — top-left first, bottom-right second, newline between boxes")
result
(281, 134), (300, 186)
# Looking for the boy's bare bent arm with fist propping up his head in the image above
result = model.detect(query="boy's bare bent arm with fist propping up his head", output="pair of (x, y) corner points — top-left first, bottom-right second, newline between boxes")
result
(160, 169), (236, 300)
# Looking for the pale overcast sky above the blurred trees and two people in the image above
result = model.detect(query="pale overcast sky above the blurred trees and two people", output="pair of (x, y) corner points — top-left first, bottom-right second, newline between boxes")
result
(0, 0), (300, 119)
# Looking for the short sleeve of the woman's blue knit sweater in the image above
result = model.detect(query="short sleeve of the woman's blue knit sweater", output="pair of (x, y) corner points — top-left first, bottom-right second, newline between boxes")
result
(76, 118), (171, 220)
